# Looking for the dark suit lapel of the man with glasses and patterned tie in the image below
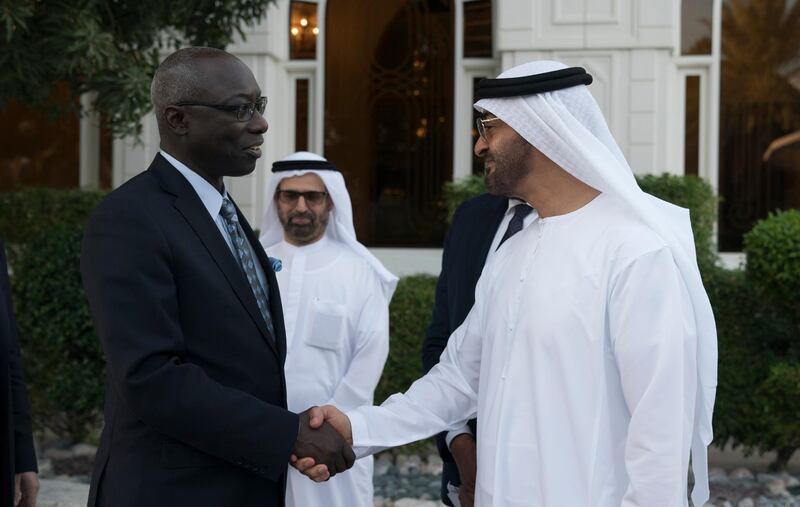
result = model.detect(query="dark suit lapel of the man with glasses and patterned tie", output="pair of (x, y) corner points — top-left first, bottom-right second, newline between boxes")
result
(150, 155), (280, 357)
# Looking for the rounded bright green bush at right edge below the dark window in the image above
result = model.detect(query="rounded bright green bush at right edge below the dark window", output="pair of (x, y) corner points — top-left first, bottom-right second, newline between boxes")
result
(744, 209), (800, 314)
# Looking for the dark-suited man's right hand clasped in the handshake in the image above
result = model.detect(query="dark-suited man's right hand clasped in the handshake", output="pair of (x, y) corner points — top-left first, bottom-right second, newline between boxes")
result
(292, 407), (356, 481)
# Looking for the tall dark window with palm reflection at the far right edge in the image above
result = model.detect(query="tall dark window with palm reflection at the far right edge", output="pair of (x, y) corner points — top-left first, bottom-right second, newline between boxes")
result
(719, 0), (800, 251)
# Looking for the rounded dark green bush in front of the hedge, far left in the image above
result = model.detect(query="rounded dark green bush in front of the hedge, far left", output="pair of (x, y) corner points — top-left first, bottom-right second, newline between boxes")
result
(12, 224), (105, 441)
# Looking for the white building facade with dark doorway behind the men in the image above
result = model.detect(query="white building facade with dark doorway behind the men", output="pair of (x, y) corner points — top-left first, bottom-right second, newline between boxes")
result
(81, 0), (800, 274)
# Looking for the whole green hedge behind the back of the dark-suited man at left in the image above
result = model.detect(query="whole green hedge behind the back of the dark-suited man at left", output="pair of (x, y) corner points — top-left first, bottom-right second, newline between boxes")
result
(0, 189), (105, 441)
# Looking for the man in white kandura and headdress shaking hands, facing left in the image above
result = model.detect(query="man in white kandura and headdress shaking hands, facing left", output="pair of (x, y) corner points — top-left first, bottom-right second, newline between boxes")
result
(296, 62), (716, 507)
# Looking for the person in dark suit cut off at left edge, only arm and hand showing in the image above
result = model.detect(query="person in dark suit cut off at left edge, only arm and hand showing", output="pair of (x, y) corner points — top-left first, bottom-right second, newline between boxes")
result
(0, 241), (39, 507)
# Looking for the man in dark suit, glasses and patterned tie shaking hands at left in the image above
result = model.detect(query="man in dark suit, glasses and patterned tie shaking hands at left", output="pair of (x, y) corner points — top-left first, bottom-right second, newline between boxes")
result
(81, 48), (354, 507)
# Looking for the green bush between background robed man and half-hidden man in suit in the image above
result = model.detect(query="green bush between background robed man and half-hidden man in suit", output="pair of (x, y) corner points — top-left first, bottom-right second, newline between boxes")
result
(375, 275), (436, 404)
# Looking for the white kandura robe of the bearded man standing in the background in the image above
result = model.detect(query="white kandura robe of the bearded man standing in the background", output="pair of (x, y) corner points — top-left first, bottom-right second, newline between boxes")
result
(267, 236), (389, 507)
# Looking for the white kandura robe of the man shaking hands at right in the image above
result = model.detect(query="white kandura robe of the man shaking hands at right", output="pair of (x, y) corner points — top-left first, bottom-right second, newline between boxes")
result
(348, 194), (697, 507)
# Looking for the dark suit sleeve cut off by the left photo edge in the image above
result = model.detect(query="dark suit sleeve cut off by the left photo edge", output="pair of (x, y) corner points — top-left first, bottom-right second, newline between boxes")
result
(0, 243), (38, 473)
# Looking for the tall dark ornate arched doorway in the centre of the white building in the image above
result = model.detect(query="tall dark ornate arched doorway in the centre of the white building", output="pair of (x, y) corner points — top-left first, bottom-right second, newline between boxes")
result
(324, 0), (453, 247)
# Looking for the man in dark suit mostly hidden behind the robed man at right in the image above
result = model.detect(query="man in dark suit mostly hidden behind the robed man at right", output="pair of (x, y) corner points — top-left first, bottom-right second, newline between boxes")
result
(422, 134), (535, 507)
